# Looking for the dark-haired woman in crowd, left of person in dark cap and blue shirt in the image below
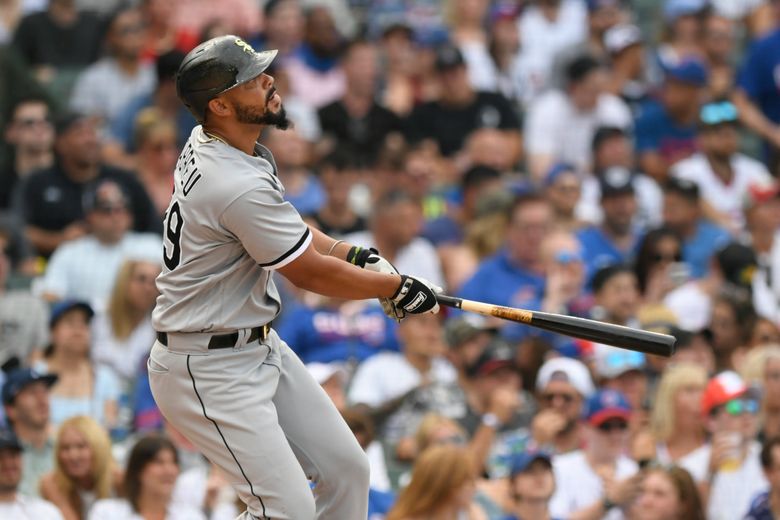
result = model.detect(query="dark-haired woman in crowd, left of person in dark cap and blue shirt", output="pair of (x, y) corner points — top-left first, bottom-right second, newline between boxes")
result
(634, 227), (690, 304)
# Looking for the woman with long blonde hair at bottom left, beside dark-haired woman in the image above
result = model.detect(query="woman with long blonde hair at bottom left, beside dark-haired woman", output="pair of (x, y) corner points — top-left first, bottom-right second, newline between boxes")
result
(40, 416), (121, 520)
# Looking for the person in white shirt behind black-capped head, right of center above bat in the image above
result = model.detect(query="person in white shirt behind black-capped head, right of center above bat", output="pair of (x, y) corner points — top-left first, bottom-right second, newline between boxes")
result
(576, 126), (663, 230)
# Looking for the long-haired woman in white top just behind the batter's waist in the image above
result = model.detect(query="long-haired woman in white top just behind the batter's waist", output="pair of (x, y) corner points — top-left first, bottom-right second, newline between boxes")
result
(92, 260), (160, 391)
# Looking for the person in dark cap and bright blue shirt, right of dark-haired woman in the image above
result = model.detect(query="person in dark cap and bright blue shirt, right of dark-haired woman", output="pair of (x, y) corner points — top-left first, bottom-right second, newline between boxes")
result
(664, 177), (729, 278)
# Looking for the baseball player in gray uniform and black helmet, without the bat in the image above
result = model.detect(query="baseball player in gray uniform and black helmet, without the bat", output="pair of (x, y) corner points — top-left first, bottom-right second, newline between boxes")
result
(148, 36), (440, 520)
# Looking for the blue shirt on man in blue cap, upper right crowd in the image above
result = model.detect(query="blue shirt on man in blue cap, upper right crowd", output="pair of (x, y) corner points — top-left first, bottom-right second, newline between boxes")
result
(635, 101), (696, 164)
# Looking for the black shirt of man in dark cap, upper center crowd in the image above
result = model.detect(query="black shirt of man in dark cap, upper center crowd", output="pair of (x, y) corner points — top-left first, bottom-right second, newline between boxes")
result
(406, 92), (520, 156)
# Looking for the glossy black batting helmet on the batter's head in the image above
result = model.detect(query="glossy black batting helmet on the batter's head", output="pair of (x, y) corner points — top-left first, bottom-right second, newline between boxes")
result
(176, 35), (277, 123)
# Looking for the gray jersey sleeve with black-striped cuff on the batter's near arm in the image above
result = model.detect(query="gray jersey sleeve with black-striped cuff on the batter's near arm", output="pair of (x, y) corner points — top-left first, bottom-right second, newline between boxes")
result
(222, 188), (312, 270)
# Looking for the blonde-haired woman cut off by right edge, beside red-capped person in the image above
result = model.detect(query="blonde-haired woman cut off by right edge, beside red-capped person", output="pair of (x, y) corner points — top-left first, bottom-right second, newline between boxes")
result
(741, 344), (780, 439)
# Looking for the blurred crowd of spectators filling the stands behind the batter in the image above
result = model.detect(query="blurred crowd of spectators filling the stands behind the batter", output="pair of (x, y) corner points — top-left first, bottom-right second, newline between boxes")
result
(0, 0), (780, 520)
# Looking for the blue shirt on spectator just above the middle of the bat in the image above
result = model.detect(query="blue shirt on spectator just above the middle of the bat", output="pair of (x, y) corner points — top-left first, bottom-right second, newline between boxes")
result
(458, 251), (544, 309)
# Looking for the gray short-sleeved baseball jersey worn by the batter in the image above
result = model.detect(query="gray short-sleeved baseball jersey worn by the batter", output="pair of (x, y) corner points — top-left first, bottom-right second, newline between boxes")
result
(152, 126), (312, 332)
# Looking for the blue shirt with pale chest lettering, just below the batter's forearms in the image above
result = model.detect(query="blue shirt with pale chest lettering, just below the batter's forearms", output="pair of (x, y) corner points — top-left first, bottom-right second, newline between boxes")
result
(274, 305), (400, 363)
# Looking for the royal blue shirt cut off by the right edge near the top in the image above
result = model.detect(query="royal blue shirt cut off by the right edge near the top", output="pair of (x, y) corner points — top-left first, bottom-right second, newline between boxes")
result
(737, 29), (780, 123)
